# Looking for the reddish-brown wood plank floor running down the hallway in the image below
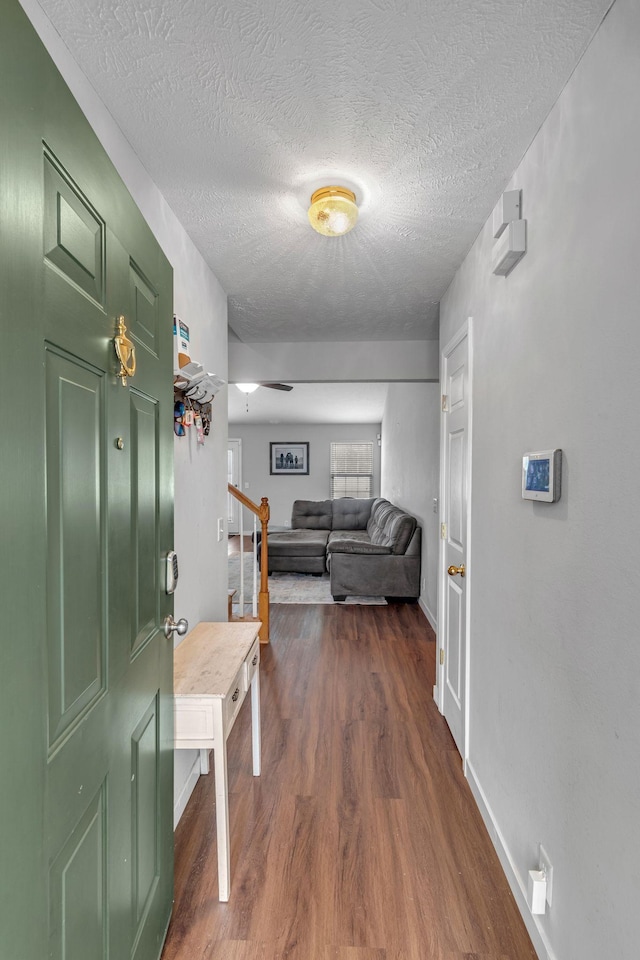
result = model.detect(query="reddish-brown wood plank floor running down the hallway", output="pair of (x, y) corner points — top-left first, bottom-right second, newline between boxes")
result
(163, 605), (535, 960)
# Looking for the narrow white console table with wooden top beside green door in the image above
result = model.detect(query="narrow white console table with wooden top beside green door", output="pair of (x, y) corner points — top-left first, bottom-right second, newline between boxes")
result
(173, 621), (261, 901)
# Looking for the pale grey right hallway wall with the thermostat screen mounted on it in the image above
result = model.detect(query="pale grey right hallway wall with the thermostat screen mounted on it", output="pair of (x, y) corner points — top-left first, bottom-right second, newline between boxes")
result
(441, 0), (640, 960)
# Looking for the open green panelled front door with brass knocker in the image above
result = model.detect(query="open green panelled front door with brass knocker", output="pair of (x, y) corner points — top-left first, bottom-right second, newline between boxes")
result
(0, 0), (173, 960)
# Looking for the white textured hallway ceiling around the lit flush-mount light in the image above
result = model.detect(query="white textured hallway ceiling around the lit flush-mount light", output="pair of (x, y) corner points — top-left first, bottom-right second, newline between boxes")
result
(40, 0), (611, 341)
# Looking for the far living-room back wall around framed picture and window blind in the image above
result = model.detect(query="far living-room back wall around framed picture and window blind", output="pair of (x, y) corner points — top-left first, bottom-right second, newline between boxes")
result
(229, 420), (380, 532)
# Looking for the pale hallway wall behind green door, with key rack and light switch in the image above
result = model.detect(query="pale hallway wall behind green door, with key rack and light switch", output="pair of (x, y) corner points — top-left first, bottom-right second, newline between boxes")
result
(20, 0), (227, 818)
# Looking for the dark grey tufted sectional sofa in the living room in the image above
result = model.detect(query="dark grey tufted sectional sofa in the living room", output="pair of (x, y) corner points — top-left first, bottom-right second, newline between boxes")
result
(269, 497), (421, 602)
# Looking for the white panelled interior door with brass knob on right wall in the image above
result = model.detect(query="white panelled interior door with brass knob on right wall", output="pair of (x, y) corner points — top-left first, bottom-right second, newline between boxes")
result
(438, 325), (471, 760)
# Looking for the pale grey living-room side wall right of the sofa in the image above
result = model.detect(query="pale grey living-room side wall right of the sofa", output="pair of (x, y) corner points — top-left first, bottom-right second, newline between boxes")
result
(381, 383), (440, 629)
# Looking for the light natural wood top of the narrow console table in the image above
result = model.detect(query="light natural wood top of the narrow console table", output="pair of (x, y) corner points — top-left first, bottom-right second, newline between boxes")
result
(173, 620), (261, 697)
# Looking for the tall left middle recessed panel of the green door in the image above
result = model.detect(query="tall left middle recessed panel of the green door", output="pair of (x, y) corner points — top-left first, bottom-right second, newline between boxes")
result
(44, 345), (107, 750)
